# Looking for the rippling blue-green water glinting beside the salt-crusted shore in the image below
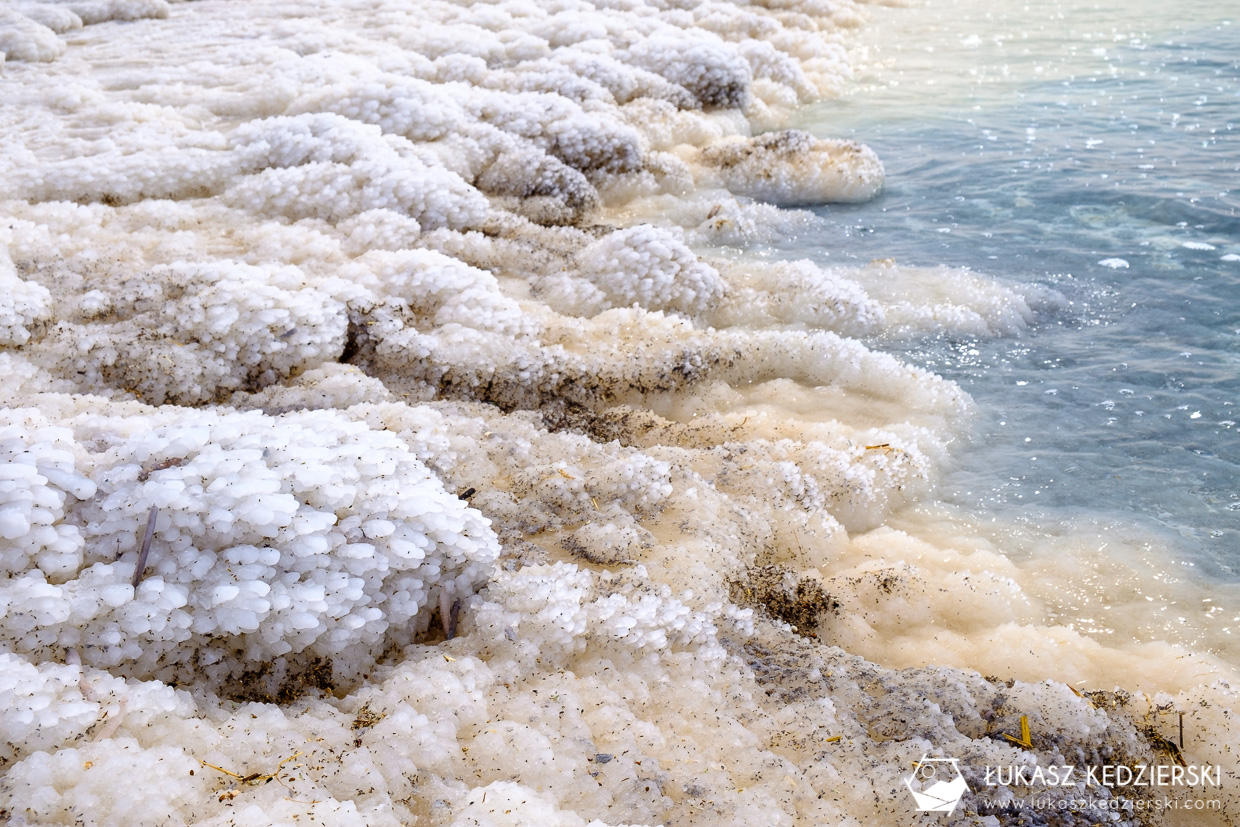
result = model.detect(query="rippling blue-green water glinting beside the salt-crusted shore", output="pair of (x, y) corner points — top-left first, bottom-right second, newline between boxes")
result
(785, 0), (1240, 582)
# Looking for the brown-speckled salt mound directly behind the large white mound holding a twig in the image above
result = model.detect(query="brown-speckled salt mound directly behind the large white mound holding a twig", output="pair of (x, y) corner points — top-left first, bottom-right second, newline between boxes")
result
(31, 260), (347, 404)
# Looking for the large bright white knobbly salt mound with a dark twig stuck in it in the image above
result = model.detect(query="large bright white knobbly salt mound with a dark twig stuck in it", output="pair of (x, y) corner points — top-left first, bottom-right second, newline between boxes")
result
(0, 410), (498, 684)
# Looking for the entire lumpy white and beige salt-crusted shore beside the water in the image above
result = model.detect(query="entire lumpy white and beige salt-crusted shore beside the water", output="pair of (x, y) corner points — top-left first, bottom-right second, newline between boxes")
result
(0, 0), (1240, 827)
